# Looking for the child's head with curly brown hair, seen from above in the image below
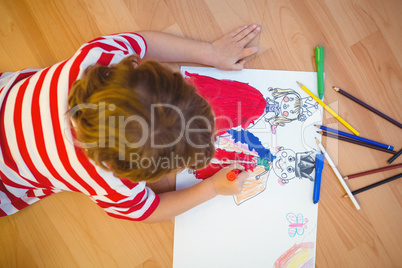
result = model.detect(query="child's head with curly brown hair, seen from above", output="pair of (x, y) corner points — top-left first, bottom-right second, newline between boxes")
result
(68, 56), (215, 181)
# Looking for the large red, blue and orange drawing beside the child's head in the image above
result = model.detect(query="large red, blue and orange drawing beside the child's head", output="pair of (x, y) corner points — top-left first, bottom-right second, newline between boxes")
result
(185, 72), (274, 205)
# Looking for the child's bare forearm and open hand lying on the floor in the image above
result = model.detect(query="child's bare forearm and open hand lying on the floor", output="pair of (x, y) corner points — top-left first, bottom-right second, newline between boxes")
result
(138, 24), (261, 70)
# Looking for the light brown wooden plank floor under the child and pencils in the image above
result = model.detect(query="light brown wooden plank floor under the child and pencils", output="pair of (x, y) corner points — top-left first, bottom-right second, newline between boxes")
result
(0, 0), (402, 267)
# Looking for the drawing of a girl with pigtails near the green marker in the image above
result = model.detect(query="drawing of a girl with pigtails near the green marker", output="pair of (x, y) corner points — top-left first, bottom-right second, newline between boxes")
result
(251, 87), (318, 134)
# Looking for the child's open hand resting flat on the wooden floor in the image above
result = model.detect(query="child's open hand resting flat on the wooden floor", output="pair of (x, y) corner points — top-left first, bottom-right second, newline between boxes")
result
(212, 24), (261, 71)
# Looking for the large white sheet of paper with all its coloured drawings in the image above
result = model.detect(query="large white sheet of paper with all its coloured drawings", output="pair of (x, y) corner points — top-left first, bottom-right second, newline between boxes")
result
(175, 67), (323, 268)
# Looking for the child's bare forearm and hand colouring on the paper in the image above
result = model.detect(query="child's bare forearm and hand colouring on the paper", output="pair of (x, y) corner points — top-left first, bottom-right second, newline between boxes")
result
(144, 164), (249, 223)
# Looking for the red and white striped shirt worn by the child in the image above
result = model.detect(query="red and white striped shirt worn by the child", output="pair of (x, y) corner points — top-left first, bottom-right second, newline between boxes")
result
(0, 33), (159, 220)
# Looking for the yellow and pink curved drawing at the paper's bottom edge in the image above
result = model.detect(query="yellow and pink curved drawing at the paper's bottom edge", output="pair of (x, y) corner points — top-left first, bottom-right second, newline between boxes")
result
(274, 242), (314, 268)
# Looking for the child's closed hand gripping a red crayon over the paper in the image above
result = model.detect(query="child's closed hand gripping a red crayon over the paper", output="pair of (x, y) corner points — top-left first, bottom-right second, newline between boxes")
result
(210, 163), (250, 195)
